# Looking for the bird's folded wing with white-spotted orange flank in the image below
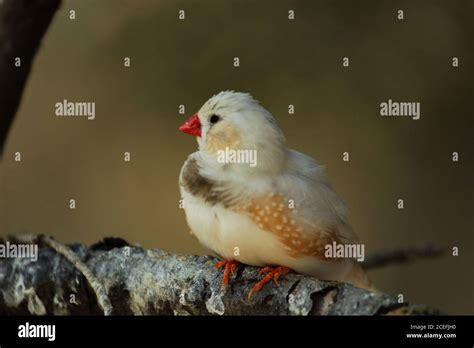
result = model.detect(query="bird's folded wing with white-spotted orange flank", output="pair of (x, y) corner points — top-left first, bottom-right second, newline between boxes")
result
(234, 150), (357, 259)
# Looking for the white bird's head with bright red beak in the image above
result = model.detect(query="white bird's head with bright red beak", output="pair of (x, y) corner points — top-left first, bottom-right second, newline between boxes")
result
(179, 91), (286, 173)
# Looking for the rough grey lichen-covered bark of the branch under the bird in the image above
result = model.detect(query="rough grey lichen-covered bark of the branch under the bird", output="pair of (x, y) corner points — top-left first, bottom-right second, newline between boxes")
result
(0, 240), (439, 315)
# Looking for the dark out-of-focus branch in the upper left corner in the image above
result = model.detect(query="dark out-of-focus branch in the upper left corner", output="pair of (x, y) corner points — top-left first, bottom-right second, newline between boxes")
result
(0, 0), (61, 156)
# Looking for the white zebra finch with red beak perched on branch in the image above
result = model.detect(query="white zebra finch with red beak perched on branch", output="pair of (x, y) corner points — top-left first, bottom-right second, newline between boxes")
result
(179, 90), (373, 297)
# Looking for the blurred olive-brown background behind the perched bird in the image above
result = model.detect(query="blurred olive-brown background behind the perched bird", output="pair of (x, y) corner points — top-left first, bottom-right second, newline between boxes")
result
(0, 0), (474, 314)
